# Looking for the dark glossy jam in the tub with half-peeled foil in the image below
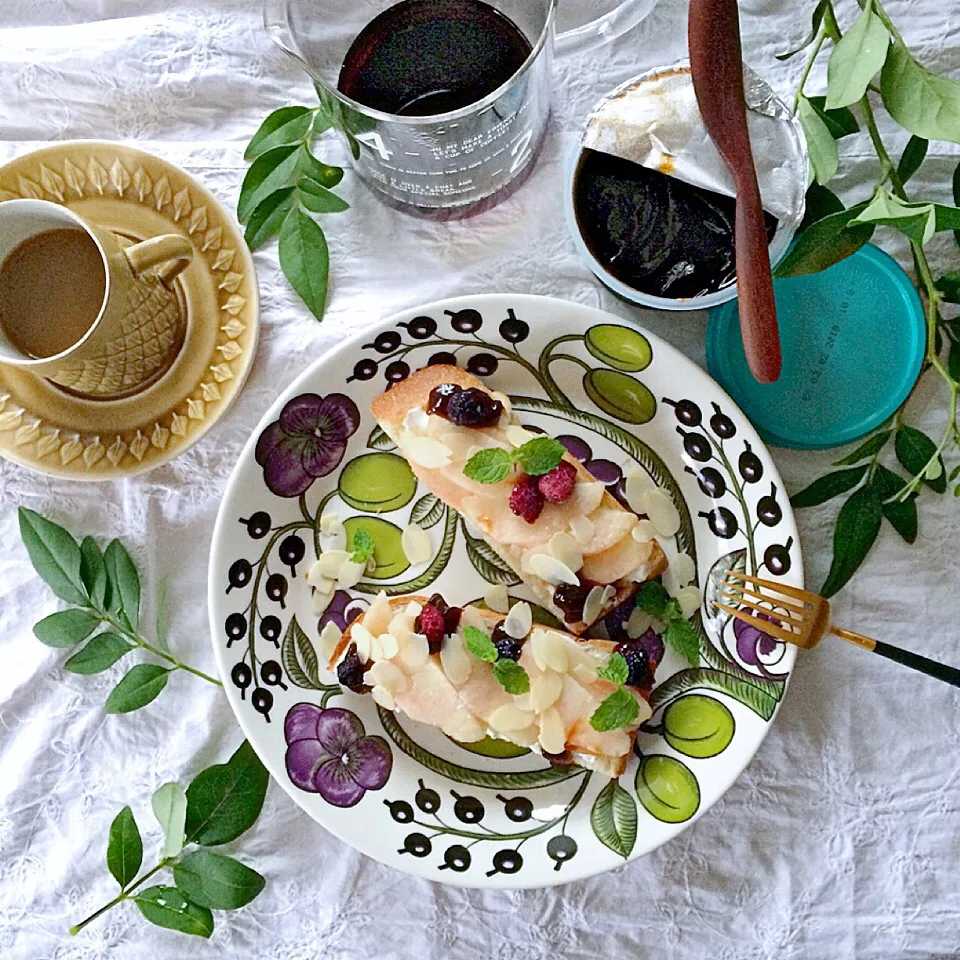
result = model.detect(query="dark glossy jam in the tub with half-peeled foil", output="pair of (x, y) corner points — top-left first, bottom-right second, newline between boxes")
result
(573, 150), (777, 300)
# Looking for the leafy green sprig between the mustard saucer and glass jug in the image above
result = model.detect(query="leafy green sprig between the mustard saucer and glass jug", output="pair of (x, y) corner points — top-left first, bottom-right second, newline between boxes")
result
(237, 104), (349, 320)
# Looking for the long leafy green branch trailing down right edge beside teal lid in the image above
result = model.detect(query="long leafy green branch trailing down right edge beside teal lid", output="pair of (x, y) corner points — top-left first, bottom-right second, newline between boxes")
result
(776, 0), (960, 596)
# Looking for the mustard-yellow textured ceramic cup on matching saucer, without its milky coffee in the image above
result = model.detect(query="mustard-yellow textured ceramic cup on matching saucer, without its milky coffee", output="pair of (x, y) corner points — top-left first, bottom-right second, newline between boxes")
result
(0, 200), (193, 400)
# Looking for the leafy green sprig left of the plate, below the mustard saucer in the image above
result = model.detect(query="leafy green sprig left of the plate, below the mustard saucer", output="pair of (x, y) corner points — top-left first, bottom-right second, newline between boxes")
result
(19, 507), (223, 713)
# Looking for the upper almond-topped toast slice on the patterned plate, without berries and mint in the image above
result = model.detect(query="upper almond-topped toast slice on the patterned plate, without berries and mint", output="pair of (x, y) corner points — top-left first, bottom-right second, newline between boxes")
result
(371, 364), (667, 635)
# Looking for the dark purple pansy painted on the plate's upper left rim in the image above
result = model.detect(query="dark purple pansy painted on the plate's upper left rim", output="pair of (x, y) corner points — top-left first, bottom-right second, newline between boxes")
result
(255, 393), (360, 497)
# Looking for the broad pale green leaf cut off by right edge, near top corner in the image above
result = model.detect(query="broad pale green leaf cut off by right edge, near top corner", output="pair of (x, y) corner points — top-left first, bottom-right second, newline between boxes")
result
(880, 41), (960, 143)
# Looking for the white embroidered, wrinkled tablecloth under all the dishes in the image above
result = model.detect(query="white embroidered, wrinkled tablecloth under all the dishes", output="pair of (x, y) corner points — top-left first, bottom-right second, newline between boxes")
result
(0, 0), (960, 960)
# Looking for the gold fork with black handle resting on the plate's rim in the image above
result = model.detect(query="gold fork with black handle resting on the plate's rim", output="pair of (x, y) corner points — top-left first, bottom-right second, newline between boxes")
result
(713, 570), (960, 687)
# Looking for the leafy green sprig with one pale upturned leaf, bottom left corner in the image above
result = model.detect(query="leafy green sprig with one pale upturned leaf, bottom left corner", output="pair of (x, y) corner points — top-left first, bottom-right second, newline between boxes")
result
(70, 740), (269, 937)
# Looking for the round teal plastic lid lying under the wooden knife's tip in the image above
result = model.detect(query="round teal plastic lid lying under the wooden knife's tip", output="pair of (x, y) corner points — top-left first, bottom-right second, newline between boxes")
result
(707, 244), (926, 450)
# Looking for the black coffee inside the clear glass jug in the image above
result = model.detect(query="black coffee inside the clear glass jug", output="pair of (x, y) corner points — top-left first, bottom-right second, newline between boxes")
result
(337, 0), (533, 117)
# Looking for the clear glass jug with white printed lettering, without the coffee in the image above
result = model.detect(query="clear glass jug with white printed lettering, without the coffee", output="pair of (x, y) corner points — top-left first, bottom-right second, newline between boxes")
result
(264, 0), (656, 218)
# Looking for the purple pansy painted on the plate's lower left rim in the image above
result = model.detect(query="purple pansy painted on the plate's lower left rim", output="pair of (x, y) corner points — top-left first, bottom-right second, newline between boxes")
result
(283, 703), (393, 807)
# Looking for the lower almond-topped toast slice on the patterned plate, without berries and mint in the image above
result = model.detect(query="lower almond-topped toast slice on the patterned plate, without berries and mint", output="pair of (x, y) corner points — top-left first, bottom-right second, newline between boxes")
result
(329, 594), (650, 777)
